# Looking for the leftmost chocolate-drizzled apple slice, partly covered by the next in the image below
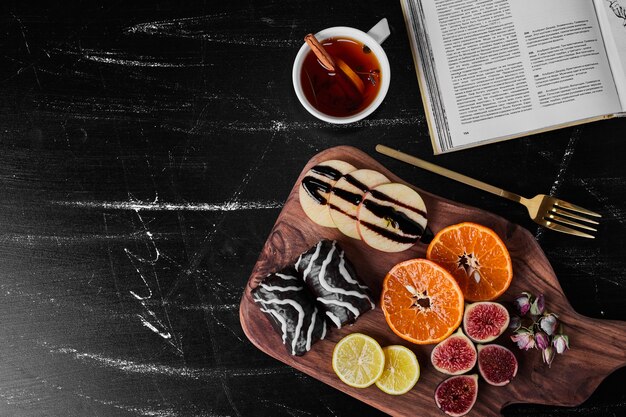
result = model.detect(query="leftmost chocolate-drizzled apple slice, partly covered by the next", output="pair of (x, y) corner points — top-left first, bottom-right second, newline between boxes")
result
(300, 159), (356, 227)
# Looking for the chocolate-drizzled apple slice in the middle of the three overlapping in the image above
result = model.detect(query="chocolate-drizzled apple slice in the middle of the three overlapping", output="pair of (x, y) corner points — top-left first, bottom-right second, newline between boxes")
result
(328, 169), (389, 239)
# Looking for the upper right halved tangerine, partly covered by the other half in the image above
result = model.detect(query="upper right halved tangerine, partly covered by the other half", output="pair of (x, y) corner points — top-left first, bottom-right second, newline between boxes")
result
(426, 223), (513, 301)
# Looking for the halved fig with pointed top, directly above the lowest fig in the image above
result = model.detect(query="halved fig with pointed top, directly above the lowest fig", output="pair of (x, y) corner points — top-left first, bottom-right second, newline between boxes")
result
(430, 328), (477, 375)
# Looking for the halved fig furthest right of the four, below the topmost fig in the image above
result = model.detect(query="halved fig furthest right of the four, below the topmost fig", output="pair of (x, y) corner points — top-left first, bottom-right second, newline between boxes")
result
(478, 344), (518, 386)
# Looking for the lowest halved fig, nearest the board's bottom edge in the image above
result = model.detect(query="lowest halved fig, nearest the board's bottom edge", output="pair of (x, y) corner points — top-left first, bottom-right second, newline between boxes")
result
(435, 374), (478, 417)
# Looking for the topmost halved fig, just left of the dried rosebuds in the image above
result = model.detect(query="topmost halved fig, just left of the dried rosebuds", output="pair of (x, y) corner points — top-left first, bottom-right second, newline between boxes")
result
(463, 301), (510, 343)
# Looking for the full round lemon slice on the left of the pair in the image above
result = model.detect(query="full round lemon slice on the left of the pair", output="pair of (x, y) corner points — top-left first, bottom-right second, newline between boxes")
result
(333, 333), (385, 388)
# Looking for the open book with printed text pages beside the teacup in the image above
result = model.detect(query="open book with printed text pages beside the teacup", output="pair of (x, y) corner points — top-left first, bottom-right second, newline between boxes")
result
(401, 0), (626, 154)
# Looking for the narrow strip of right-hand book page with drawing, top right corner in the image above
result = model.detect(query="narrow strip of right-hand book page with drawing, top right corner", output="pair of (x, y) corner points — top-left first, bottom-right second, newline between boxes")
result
(594, 0), (626, 112)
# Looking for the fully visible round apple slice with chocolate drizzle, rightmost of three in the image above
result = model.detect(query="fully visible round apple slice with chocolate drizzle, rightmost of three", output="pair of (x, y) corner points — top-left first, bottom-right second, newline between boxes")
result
(357, 183), (426, 252)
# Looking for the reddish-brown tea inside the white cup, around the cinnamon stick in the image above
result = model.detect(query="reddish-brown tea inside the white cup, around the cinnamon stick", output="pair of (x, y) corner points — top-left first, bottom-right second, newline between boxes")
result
(301, 37), (383, 117)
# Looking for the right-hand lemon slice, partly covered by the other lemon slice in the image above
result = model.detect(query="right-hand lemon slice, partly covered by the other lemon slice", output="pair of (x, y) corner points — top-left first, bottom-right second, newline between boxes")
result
(376, 345), (420, 395)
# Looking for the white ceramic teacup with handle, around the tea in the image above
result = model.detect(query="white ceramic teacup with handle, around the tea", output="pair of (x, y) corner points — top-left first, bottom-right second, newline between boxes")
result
(292, 19), (391, 124)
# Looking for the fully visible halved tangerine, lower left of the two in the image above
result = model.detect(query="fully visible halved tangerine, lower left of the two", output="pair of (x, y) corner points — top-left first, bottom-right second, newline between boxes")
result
(381, 259), (464, 345)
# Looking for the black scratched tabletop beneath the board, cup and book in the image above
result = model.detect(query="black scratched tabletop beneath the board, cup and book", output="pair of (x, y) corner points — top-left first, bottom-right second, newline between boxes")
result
(0, 0), (626, 417)
